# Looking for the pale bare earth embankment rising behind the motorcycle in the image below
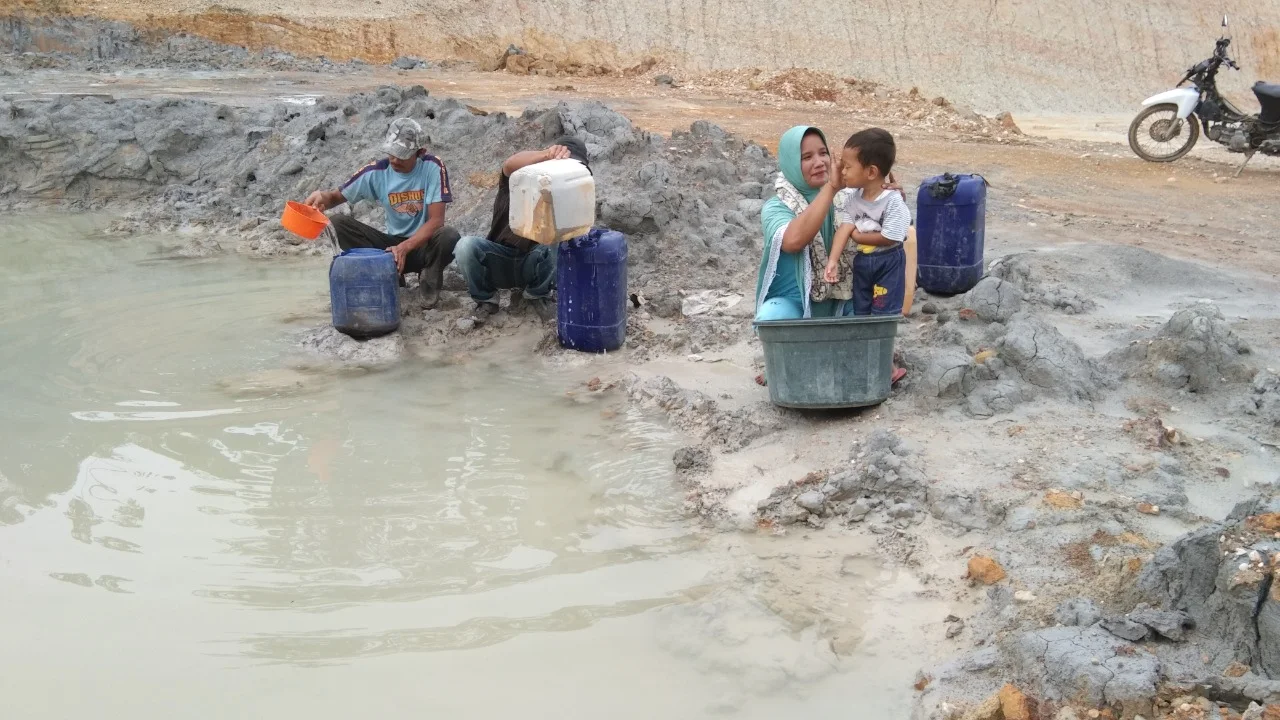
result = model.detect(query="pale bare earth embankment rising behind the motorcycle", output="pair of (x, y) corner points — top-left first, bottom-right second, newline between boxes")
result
(17, 0), (1280, 111)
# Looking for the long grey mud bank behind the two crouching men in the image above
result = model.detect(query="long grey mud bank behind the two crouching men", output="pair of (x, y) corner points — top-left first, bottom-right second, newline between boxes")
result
(0, 86), (774, 296)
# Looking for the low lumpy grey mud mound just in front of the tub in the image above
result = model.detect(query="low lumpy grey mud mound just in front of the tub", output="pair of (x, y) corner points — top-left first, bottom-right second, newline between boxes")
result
(756, 429), (927, 529)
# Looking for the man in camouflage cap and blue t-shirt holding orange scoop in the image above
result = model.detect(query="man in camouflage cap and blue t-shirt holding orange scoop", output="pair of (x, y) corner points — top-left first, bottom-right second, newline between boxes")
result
(306, 118), (458, 307)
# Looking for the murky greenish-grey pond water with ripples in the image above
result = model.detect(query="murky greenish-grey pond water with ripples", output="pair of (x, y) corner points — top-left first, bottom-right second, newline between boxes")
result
(0, 217), (942, 719)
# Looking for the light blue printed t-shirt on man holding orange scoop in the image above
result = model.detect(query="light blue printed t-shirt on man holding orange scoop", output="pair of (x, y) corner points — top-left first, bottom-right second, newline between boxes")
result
(340, 150), (453, 237)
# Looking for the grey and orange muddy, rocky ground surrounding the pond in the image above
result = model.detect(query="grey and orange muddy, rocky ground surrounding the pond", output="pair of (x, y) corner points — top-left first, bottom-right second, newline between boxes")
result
(0, 16), (1280, 720)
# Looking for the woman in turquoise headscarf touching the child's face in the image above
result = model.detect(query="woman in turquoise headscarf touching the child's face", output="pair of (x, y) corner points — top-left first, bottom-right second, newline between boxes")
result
(755, 126), (852, 320)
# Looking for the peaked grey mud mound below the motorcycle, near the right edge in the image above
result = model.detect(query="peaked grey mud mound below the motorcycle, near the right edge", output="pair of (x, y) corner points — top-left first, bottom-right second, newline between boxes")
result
(1107, 302), (1253, 392)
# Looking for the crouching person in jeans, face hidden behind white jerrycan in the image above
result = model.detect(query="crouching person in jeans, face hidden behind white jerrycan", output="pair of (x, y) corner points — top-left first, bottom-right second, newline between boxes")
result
(454, 136), (590, 320)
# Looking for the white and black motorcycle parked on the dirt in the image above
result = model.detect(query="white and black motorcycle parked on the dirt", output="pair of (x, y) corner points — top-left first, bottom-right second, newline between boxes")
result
(1129, 18), (1280, 176)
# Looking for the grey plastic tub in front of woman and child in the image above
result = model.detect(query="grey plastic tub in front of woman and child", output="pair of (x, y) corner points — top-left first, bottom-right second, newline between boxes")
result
(755, 315), (902, 409)
